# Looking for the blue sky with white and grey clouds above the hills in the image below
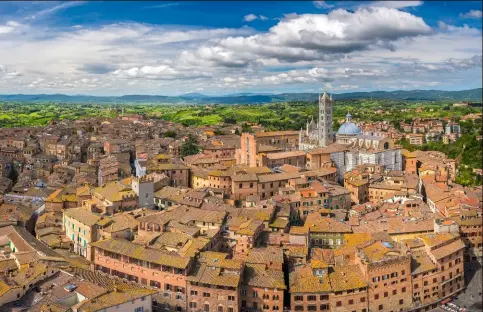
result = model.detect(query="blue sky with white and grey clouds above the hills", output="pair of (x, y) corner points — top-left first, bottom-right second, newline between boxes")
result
(0, 1), (482, 95)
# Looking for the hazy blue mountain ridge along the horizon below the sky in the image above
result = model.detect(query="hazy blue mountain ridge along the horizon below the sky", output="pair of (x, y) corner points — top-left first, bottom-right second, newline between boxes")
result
(0, 88), (483, 104)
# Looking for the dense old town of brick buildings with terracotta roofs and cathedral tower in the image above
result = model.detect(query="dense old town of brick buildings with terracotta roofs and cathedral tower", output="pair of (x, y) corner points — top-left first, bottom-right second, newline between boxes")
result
(0, 93), (483, 312)
